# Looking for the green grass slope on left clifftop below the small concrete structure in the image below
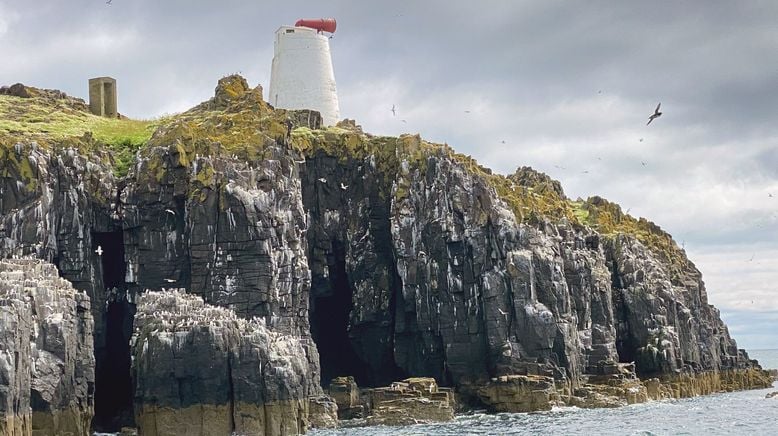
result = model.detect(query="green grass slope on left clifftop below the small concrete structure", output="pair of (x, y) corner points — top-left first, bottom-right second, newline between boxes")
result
(0, 95), (162, 176)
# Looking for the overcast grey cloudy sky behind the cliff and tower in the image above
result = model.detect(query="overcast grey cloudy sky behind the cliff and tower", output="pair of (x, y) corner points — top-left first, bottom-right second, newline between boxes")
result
(0, 0), (778, 349)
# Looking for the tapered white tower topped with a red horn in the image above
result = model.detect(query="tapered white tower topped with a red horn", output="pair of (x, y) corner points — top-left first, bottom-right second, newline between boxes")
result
(268, 18), (340, 126)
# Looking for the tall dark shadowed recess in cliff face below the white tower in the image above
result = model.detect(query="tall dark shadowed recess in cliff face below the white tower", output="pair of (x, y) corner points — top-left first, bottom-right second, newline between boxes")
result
(300, 153), (406, 386)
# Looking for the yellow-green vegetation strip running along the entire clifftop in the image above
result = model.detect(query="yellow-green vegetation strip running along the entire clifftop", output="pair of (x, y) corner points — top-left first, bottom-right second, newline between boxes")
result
(0, 75), (688, 272)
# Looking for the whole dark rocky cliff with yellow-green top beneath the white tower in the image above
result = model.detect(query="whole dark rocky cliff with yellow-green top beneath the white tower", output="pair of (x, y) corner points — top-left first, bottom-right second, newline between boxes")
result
(0, 76), (761, 434)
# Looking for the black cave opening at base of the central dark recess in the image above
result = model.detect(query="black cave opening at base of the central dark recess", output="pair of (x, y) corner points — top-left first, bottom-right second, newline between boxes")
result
(310, 241), (368, 386)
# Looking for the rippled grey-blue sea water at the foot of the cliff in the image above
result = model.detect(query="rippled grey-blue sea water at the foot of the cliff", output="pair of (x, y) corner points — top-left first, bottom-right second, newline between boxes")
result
(309, 350), (778, 436)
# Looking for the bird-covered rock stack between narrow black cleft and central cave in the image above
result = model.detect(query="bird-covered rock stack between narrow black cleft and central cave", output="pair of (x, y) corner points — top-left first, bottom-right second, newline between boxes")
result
(133, 290), (321, 436)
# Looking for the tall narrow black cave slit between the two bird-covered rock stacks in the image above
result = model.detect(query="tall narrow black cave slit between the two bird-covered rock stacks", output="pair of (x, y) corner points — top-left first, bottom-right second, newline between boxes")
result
(92, 230), (135, 432)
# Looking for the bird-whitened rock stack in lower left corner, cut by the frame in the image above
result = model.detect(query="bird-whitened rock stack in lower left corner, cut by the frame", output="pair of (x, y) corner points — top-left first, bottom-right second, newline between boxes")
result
(0, 260), (95, 435)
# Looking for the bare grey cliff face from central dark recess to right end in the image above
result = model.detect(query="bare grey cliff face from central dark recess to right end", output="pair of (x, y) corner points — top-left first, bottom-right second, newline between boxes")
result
(303, 137), (750, 386)
